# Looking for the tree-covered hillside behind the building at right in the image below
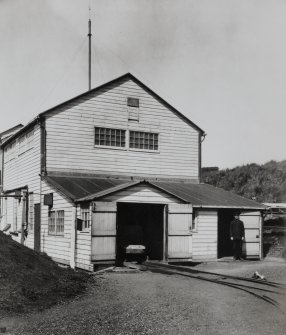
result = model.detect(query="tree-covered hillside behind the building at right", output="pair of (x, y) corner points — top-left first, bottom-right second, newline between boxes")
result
(202, 160), (286, 202)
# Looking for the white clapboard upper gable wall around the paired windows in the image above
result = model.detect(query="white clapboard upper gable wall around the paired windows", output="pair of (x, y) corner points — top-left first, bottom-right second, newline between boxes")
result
(46, 80), (199, 180)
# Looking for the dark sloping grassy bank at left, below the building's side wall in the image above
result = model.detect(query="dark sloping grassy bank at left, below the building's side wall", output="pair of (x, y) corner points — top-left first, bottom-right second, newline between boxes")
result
(0, 232), (90, 313)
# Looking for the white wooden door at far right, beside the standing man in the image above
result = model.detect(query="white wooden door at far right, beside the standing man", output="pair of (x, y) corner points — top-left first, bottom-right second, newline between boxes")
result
(240, 212), (262, 258)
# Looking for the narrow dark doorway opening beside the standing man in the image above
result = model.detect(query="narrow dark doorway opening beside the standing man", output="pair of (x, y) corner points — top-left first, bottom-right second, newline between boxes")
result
(218, 209), (234, 258)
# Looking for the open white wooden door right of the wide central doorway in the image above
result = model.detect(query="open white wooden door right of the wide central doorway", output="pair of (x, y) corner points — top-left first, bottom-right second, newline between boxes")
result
(168, 204), (193, 258)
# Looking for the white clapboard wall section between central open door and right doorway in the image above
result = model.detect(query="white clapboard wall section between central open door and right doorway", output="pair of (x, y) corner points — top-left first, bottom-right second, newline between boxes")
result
(192, 210), (218, 260)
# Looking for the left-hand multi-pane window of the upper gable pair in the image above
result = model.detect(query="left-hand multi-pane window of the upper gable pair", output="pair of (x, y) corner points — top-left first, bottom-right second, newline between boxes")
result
(94, 127), (125, 148)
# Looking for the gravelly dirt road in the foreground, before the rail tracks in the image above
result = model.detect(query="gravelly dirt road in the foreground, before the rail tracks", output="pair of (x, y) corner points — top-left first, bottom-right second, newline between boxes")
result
(0, 262), (286, 335)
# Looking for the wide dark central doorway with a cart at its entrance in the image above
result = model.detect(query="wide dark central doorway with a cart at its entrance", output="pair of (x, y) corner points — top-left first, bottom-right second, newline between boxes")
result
(116, 203), (164, 263)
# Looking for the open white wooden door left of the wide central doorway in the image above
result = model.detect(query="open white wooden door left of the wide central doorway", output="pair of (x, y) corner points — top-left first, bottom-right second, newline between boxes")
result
(91, 202), (117, 261)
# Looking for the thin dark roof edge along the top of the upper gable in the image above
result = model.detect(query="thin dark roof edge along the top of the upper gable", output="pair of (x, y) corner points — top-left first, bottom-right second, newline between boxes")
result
(5, 73), (205, 148)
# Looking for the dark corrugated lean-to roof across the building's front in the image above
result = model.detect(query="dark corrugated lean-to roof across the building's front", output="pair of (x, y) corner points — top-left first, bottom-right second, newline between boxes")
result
(45, 176), (266, 209)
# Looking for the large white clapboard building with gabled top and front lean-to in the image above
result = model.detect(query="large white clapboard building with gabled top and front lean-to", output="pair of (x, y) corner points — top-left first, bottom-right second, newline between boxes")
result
(1, 73), (264, 270)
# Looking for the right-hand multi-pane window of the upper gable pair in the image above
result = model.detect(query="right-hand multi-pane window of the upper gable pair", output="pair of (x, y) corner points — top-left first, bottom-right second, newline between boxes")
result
(129, 130), (158, 150)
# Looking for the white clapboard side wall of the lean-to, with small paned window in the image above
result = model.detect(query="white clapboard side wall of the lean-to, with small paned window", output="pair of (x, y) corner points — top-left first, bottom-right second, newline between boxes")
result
(41, 181), (74, 262)
